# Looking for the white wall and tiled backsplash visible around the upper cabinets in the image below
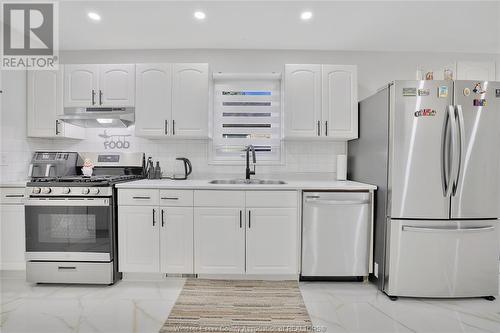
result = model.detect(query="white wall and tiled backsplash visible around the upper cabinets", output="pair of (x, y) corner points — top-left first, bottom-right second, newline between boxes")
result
(0, 50), (500, 181)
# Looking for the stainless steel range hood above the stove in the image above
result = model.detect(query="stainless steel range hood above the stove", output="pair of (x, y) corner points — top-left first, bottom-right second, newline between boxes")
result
(59, 107), (135, 128)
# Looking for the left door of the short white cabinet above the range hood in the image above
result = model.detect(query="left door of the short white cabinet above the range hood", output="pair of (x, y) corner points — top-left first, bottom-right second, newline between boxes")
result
(64, 65), (99, 107)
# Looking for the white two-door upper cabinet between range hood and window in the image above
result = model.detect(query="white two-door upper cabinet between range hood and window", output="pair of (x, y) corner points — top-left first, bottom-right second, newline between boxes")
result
(135, 64), (208, 138)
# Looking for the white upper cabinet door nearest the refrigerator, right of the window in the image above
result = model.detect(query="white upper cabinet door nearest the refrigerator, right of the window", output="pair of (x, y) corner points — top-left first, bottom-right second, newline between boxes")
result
(322, 65), (358, 140)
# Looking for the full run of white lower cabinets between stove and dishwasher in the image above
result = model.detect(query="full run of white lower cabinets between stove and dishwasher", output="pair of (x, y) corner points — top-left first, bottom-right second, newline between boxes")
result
(118, 189), (300, 276)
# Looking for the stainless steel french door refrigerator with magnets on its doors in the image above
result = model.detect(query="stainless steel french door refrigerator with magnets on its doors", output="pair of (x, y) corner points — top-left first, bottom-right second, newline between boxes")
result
(348, 81), (500, 299)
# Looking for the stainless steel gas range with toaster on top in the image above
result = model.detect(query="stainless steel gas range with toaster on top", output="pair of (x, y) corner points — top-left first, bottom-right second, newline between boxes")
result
(25, 152), (145, 284)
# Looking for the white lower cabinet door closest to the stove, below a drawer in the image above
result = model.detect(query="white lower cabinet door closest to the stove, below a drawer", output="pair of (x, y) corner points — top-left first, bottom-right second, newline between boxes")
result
(118, 206), (160, 273)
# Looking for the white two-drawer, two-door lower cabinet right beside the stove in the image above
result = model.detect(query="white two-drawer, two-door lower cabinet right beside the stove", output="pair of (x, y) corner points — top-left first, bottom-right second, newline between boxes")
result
(118, 189), (193, 274)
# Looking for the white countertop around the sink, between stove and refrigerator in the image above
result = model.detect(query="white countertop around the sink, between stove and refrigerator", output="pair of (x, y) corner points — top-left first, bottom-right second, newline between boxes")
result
(116, 179), (377, 191)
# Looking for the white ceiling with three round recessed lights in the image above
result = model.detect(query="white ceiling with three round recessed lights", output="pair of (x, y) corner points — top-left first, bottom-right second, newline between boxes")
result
(59, 0), (500, 53)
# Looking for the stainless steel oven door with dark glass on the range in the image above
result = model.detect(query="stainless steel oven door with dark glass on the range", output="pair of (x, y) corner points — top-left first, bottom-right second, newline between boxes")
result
(25, 197), (114, 262)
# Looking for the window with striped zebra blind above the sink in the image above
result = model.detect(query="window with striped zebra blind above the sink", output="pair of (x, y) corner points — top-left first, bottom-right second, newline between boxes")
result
(211, 74), (282, 164)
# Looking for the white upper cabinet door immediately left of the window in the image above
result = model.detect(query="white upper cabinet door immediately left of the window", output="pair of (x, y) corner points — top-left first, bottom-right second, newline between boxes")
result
(171, 64), (208, 138)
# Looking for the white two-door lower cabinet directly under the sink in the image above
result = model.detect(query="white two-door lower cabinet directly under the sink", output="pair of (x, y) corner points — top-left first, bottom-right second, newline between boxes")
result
(194, 191), (299, 275)
